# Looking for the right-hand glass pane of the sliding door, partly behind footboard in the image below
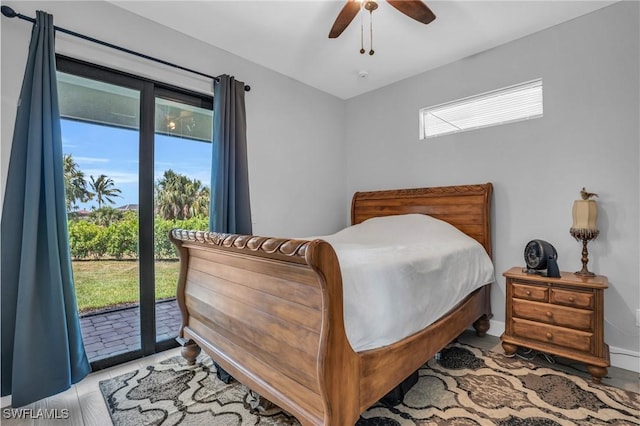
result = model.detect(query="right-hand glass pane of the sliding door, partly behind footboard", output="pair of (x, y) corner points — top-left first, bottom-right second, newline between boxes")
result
(153, 89), (213, 342)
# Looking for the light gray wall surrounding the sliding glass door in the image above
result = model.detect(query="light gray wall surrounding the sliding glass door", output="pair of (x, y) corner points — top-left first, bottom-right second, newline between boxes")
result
(0, 1), (349, 236)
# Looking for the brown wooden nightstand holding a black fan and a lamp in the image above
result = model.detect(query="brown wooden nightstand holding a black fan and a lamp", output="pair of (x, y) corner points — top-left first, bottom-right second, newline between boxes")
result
(500, 267), (611, 383)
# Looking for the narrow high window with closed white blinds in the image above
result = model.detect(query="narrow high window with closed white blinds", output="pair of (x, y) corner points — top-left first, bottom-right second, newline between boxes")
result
(420, 79), (542, 139)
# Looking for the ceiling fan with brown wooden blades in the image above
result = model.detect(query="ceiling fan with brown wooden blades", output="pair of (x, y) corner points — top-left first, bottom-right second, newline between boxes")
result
(329, 0), (436, 38)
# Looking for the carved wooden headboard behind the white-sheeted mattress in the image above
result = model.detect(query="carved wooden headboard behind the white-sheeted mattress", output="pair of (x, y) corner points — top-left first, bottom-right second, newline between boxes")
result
(351, 183), (493, 256)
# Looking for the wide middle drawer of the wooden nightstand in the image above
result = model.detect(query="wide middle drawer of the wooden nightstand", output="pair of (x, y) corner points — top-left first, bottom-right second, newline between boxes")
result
(512, 299), (594, 331)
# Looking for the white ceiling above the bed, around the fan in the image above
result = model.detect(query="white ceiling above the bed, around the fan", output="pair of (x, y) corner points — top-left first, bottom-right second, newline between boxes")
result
(112, 0), (615, 99)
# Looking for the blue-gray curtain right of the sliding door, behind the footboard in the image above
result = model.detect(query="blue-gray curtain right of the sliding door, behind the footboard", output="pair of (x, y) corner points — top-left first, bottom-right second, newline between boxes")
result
(209, 75), (252, 235)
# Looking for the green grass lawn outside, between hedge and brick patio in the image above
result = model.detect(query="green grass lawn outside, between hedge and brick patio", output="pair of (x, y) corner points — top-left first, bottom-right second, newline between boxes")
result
(72, 260), (180, 313)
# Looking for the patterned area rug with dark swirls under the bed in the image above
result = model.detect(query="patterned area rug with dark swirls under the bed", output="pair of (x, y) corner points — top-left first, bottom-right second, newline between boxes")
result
(100, 343), (640, 426)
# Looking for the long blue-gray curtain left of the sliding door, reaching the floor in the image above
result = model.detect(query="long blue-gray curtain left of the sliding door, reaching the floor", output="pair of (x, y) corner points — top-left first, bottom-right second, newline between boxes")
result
(1, 11), (90, 407)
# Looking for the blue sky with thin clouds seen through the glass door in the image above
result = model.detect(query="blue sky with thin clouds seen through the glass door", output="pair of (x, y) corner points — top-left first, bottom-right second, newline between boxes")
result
(61, 119), (211, 210)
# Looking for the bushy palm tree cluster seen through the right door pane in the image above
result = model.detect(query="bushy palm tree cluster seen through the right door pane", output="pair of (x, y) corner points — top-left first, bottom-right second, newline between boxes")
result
(156, 169), (210, 219)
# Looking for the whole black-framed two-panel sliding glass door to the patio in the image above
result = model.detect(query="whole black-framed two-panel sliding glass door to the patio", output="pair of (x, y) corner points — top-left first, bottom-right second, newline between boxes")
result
(57, 57), (212, 369)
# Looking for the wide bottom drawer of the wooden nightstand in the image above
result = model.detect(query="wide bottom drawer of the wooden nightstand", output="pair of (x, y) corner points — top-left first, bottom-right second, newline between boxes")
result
(513, 318), (593, 353)
